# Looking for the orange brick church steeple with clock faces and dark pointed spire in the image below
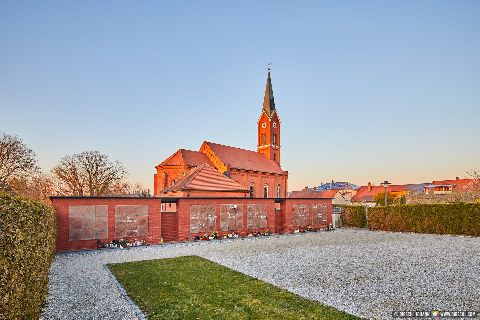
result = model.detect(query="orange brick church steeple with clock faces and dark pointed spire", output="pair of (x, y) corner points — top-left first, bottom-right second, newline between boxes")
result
(257, 64), (280, 165)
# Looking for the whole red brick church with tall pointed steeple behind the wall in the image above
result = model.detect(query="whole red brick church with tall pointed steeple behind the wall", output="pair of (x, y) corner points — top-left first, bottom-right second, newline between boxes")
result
(154, 68), (288, 198)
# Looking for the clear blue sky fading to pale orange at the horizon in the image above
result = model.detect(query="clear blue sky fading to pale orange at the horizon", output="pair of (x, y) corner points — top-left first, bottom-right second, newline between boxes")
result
(0, 1), (480, 190)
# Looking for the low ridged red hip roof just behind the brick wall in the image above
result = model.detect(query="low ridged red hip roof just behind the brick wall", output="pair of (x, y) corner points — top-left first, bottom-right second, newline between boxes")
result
(168, 164), (248, 192)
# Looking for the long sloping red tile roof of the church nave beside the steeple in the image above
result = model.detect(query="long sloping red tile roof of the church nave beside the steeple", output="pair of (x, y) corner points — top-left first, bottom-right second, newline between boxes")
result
(204, 141), (285, 174)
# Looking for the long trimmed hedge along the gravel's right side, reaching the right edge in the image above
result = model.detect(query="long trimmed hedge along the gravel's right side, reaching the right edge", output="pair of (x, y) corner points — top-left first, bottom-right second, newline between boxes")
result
(368, 203), (480, 237)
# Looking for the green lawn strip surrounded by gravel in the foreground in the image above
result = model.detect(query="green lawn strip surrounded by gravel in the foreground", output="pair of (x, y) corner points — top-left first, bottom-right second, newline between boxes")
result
(109, 256), (357, 319)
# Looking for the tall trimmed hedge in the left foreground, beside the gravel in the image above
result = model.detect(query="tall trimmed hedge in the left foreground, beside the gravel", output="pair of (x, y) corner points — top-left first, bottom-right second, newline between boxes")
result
(0, 193), (56, 319)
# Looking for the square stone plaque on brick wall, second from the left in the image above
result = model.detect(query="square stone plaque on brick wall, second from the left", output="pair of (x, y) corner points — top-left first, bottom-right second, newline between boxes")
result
(115, 205), (148, 238)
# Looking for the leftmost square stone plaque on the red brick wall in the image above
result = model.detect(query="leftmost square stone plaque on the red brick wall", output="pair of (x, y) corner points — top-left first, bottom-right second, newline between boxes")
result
(68, 205), (108, 241)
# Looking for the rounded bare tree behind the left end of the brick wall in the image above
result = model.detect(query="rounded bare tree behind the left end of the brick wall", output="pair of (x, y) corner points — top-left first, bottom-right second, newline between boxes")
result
(52, 151), (127, 196)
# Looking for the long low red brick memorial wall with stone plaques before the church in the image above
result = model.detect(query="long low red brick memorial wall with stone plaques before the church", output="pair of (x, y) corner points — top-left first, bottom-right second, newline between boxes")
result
(51, 197), (332, 251)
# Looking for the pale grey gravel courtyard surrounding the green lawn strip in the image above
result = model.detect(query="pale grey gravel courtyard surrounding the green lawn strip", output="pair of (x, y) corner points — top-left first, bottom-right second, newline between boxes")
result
(42, 229), (480, 319)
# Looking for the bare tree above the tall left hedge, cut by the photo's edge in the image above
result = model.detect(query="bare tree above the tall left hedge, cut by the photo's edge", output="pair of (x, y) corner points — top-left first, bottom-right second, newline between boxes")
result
(0, 132), (39, 190)
